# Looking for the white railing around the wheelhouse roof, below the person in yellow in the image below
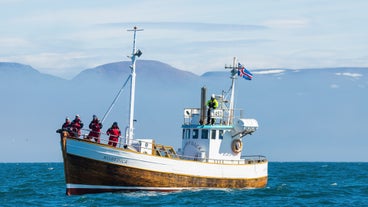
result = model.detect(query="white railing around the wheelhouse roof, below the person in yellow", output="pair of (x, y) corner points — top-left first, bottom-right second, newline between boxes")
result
(183, 107), (243, 125)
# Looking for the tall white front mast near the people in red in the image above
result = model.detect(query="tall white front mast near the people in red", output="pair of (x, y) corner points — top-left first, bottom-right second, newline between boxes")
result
(126, 26), (143, 145)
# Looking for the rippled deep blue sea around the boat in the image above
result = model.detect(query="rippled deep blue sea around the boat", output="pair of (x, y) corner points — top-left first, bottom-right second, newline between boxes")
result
(0, 162), (368, 207)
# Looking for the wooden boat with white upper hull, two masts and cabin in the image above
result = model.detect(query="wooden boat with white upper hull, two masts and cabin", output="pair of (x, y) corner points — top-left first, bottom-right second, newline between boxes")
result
(57, 27), (268, 195)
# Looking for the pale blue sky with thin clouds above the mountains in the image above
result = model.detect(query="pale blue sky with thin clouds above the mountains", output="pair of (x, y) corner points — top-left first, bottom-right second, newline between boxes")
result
(0, 0), (368, 78)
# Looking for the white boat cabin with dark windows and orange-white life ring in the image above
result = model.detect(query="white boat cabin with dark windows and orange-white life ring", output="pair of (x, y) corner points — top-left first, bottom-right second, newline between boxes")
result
(178, 88), (258, 162)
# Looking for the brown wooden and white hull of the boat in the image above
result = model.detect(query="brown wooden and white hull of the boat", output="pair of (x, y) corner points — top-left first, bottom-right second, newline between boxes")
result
(61, 137), (268, 195)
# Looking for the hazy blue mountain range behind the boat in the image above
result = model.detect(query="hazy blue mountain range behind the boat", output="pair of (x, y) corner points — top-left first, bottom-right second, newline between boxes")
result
(0, 60), (368, 162)
